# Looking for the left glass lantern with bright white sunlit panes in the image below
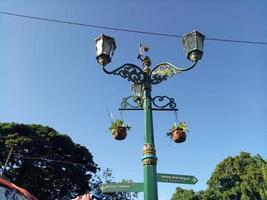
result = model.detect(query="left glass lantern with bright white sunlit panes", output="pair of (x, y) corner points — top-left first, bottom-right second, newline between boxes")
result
(95, 34), (116, 66)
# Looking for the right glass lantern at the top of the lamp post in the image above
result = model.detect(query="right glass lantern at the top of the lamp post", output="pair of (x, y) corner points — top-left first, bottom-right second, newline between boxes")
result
(182, 31), (205, 62)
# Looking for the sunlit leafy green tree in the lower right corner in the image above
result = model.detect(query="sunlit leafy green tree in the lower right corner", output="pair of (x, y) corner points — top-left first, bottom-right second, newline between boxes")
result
(202, 152), (267, 200)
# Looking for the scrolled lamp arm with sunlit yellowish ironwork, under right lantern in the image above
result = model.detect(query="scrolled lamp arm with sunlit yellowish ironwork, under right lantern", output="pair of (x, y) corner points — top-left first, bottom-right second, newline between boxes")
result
(149, 61), (197, 85)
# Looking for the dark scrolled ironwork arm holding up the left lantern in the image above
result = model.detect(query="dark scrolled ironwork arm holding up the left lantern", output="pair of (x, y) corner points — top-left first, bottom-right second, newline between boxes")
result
(102, 63), (145, 84)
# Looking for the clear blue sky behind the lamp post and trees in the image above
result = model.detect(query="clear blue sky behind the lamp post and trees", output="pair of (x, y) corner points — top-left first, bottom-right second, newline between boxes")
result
(0, 0), (267, 200)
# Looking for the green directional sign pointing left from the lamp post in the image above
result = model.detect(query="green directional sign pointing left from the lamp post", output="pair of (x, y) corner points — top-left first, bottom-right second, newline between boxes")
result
(101, 183), (144, 193)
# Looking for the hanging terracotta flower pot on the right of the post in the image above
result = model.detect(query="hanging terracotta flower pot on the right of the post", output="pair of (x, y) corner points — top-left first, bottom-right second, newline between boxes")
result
(167, 122), (189, 143)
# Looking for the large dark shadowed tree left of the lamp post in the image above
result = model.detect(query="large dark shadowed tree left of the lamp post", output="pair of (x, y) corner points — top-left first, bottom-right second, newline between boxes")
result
(0, 123), (98, 200)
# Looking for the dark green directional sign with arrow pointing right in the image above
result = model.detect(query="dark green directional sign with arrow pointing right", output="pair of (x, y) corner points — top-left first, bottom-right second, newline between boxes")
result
(157, 173), (198, 184)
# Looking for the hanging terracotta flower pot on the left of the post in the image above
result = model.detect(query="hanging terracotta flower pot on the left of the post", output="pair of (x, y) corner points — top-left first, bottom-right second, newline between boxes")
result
(108, 119), (131, 140)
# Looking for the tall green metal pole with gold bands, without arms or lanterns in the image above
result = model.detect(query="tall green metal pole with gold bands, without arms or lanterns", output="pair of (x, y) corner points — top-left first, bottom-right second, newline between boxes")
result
(142, 57), (158, 200)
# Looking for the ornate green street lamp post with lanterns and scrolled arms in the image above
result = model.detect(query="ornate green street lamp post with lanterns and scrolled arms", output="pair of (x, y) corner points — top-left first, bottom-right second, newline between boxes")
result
(95, 31), (205, 200)
